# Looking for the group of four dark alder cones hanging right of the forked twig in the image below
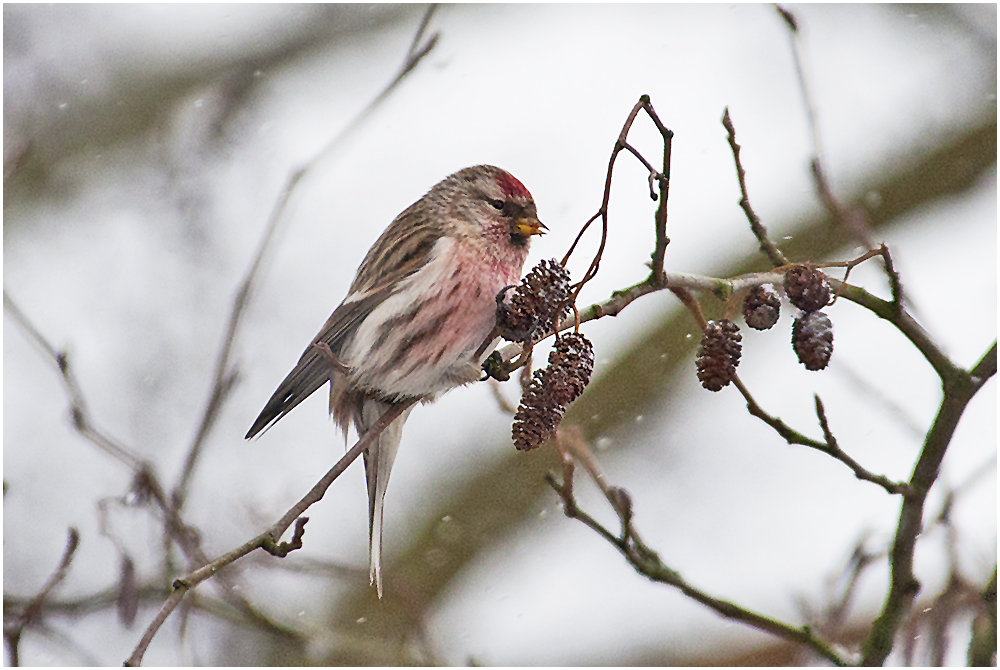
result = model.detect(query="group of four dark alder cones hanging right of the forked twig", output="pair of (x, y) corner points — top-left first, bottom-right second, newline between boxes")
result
(696, 265), (833, 391)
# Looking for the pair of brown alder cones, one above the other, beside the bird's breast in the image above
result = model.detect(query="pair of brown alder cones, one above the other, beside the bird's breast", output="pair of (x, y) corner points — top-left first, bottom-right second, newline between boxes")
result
(497, 260), (594, 451)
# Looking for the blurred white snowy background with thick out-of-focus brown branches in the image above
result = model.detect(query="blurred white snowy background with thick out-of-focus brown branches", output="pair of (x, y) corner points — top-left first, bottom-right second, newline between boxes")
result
(3, 5), (997, 665)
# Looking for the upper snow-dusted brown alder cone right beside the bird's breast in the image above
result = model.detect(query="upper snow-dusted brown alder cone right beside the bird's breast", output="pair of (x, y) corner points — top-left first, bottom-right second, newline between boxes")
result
(497, 259), (570, 342)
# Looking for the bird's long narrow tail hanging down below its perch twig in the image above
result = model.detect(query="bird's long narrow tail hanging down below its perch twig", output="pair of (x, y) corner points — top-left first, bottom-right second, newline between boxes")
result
(357, 399), (412, 598)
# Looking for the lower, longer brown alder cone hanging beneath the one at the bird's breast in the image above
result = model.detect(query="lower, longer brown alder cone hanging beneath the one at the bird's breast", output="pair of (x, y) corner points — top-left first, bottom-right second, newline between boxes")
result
(511, 333), (594, 451)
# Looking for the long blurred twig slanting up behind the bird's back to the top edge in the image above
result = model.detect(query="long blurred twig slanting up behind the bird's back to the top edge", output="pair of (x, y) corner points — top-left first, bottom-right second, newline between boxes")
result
(171, 4), (440, 509)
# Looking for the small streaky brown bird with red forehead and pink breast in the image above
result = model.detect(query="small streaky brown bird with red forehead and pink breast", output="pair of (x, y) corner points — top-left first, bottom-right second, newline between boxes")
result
(246, 165), (546, 598)
